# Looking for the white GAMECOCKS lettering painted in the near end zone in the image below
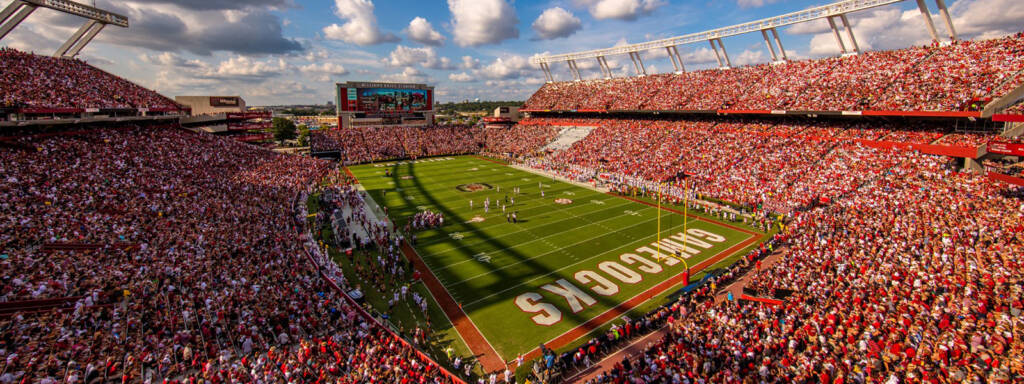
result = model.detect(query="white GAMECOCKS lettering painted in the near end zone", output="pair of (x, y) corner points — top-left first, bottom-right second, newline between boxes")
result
(515, 228), (725, 326)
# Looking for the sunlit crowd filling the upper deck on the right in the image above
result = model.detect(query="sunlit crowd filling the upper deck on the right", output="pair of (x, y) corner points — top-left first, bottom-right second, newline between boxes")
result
(523, 34), (1024, 112)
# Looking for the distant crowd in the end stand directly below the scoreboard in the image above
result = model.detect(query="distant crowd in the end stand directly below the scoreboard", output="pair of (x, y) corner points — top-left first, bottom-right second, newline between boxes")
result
(310, 126), (485, 164)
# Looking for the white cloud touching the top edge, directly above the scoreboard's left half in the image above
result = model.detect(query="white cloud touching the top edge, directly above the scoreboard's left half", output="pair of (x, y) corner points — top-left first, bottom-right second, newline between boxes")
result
(324, 0), (399, 45)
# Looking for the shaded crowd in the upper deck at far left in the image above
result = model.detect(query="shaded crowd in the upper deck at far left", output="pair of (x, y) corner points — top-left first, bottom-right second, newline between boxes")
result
(0, 48), (180, 110)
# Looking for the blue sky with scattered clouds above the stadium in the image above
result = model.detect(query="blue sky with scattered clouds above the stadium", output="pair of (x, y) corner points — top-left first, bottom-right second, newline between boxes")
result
(0, 0), (1024, 105)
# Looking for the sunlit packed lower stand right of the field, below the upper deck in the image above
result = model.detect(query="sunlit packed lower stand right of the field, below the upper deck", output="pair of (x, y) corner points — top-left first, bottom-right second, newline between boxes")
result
(487, 113), (1024, 383)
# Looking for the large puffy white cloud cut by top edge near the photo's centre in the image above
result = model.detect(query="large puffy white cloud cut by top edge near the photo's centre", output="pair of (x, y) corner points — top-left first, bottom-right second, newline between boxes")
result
(447, 0), (519, 47)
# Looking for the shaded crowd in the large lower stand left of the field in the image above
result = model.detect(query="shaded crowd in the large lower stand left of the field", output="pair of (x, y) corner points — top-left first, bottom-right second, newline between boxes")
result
(0, 126), (456, 383)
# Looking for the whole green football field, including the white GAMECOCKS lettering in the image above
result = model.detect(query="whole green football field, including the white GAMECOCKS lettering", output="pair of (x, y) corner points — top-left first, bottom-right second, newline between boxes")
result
(349, 157), (764, 360)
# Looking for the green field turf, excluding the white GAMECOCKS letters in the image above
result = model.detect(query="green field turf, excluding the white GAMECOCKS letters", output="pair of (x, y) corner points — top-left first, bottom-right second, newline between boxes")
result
(353, 158), (765, 357)
